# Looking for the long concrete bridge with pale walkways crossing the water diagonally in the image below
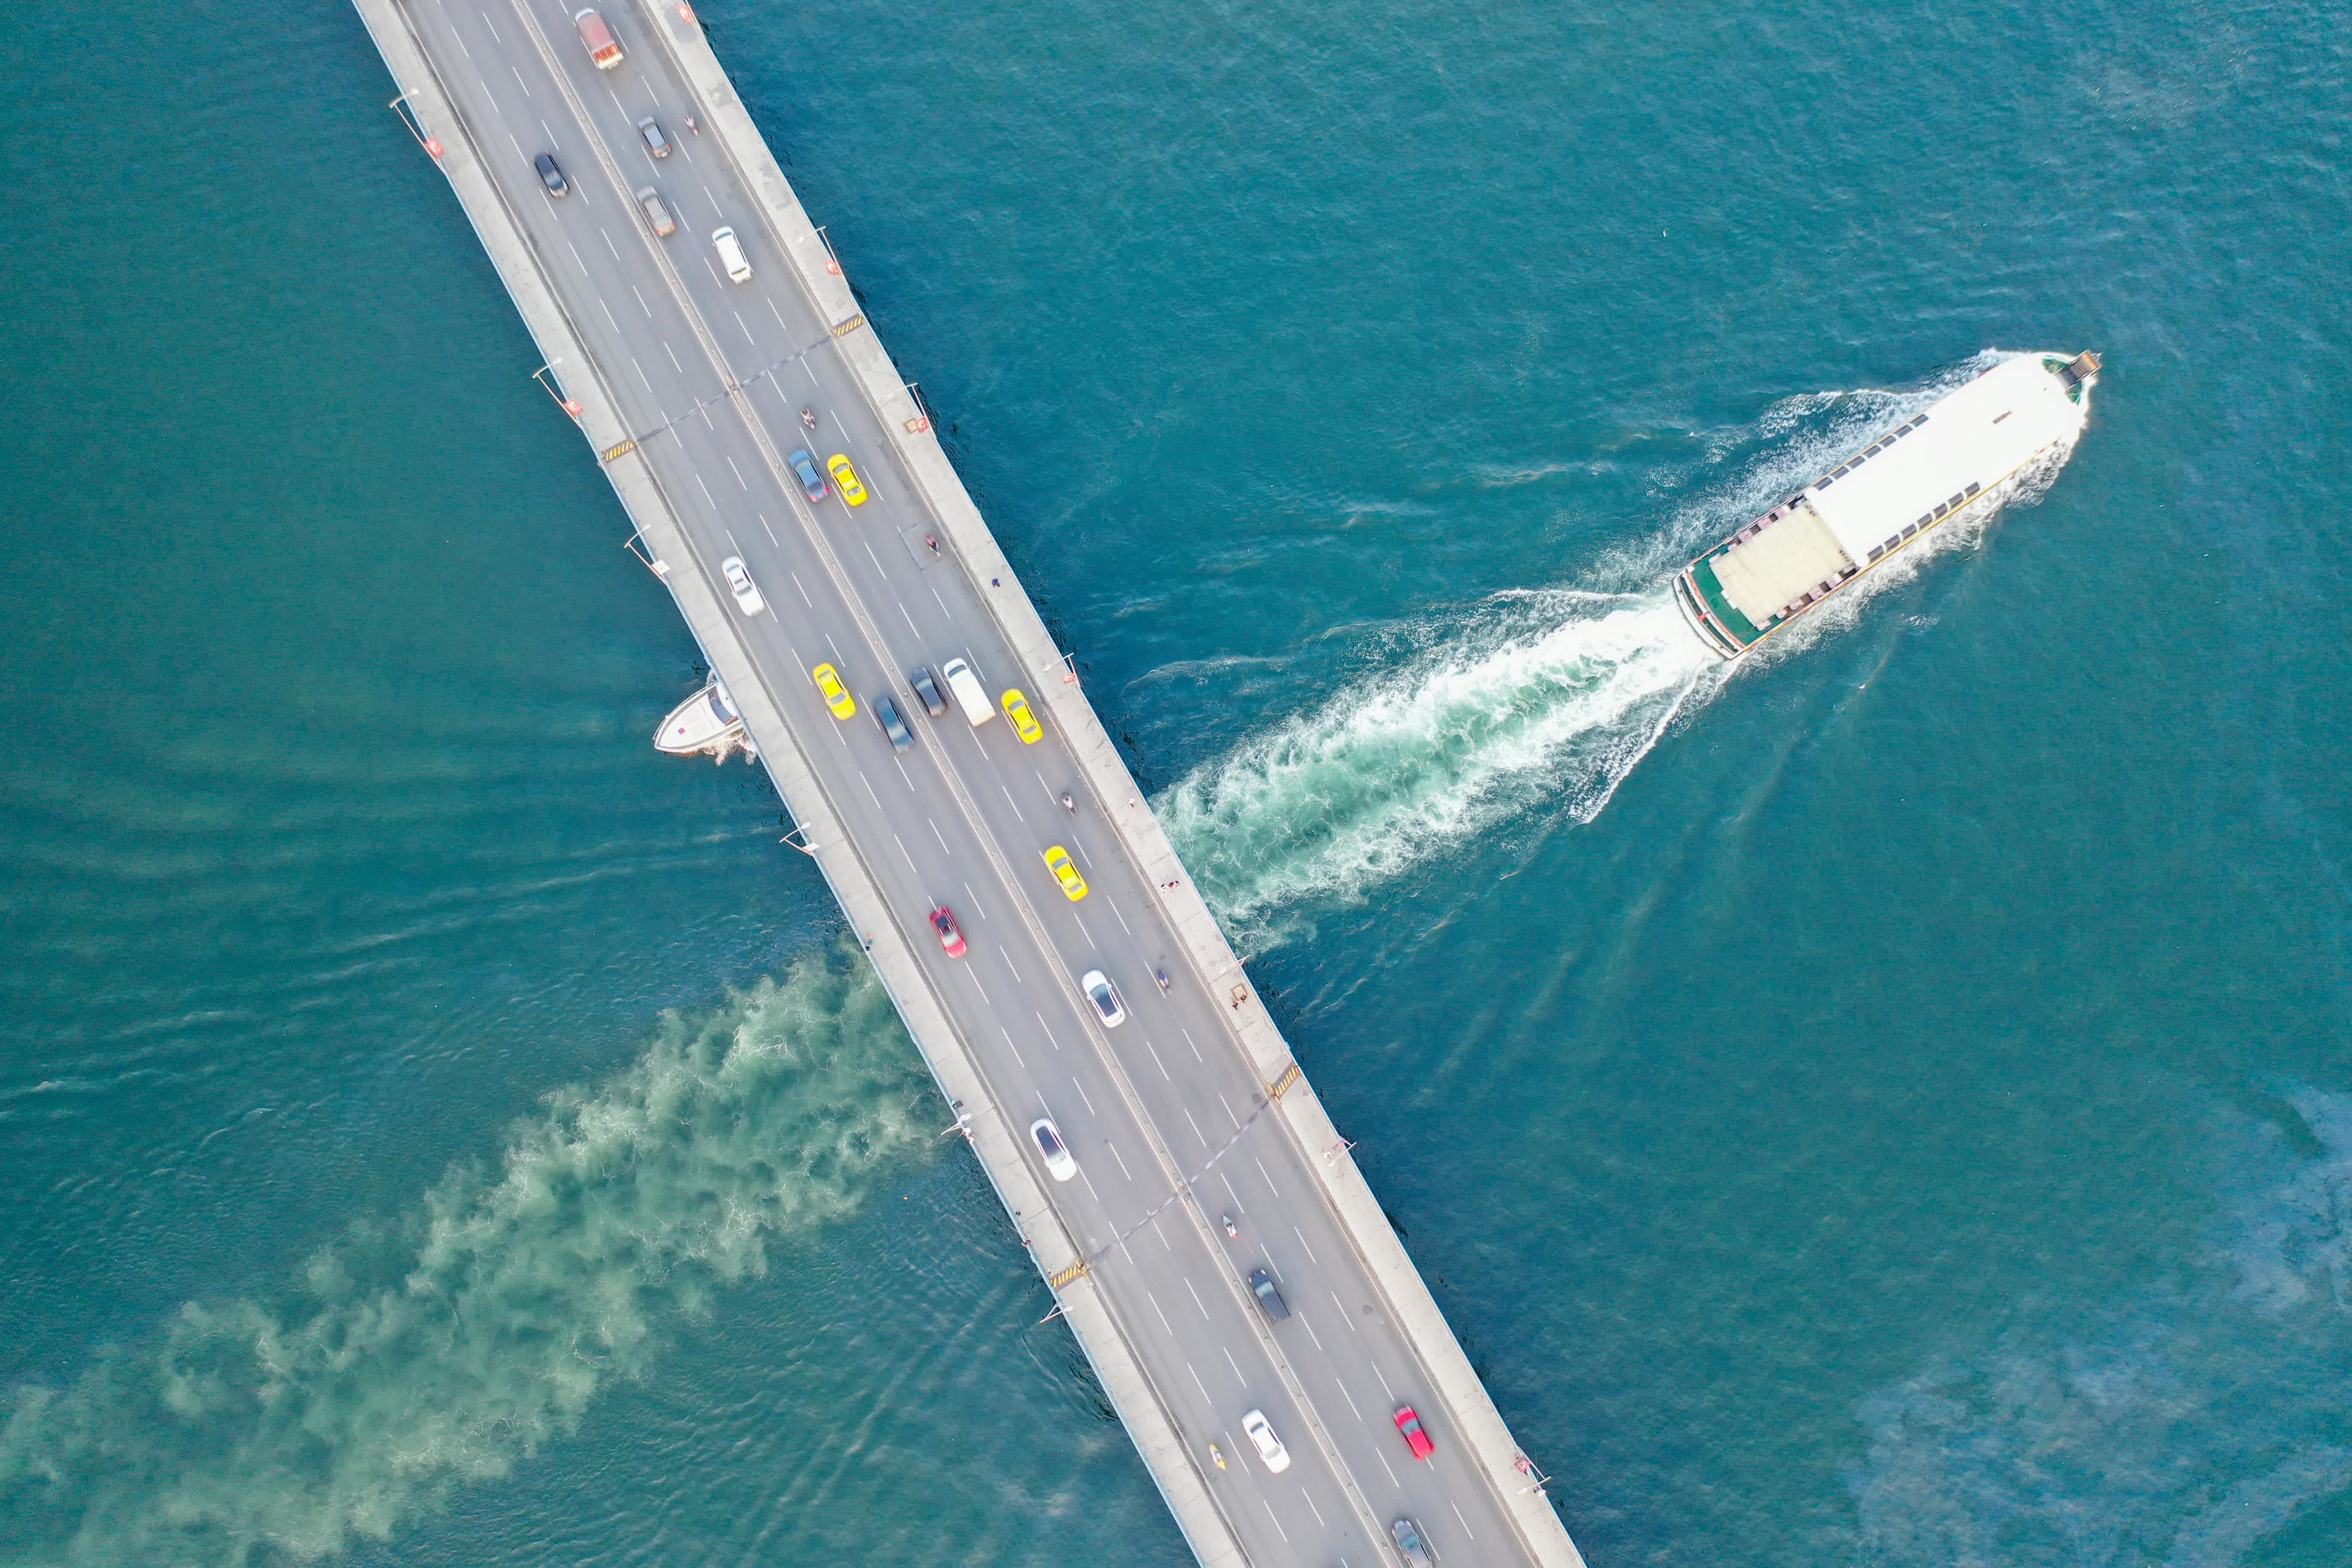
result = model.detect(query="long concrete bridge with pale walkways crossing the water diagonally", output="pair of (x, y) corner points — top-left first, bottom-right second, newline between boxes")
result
(355, 0), (1583, 1568)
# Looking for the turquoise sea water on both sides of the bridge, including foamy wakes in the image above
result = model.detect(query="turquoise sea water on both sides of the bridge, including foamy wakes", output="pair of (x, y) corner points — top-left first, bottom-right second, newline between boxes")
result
(0, 0), (2352, 1568)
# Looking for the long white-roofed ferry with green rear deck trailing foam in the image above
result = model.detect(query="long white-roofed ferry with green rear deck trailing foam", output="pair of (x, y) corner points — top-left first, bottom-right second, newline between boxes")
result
(1675, 352), (2098, 658)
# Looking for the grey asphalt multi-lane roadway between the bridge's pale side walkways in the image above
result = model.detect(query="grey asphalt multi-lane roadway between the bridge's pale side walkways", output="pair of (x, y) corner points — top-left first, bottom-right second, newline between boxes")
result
(386, 0), (1529, 1568)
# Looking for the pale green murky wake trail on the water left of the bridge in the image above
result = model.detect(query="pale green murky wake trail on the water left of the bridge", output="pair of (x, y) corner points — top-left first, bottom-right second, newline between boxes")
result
(0, 955), (931, 1568)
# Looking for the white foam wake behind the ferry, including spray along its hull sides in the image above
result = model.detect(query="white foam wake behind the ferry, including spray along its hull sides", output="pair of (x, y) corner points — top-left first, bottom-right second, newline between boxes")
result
(1155, 350), (2072, 947)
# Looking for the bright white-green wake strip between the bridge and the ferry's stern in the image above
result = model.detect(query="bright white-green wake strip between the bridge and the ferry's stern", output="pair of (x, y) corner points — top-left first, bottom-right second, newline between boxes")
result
(1160, 590), (1715, 926)
